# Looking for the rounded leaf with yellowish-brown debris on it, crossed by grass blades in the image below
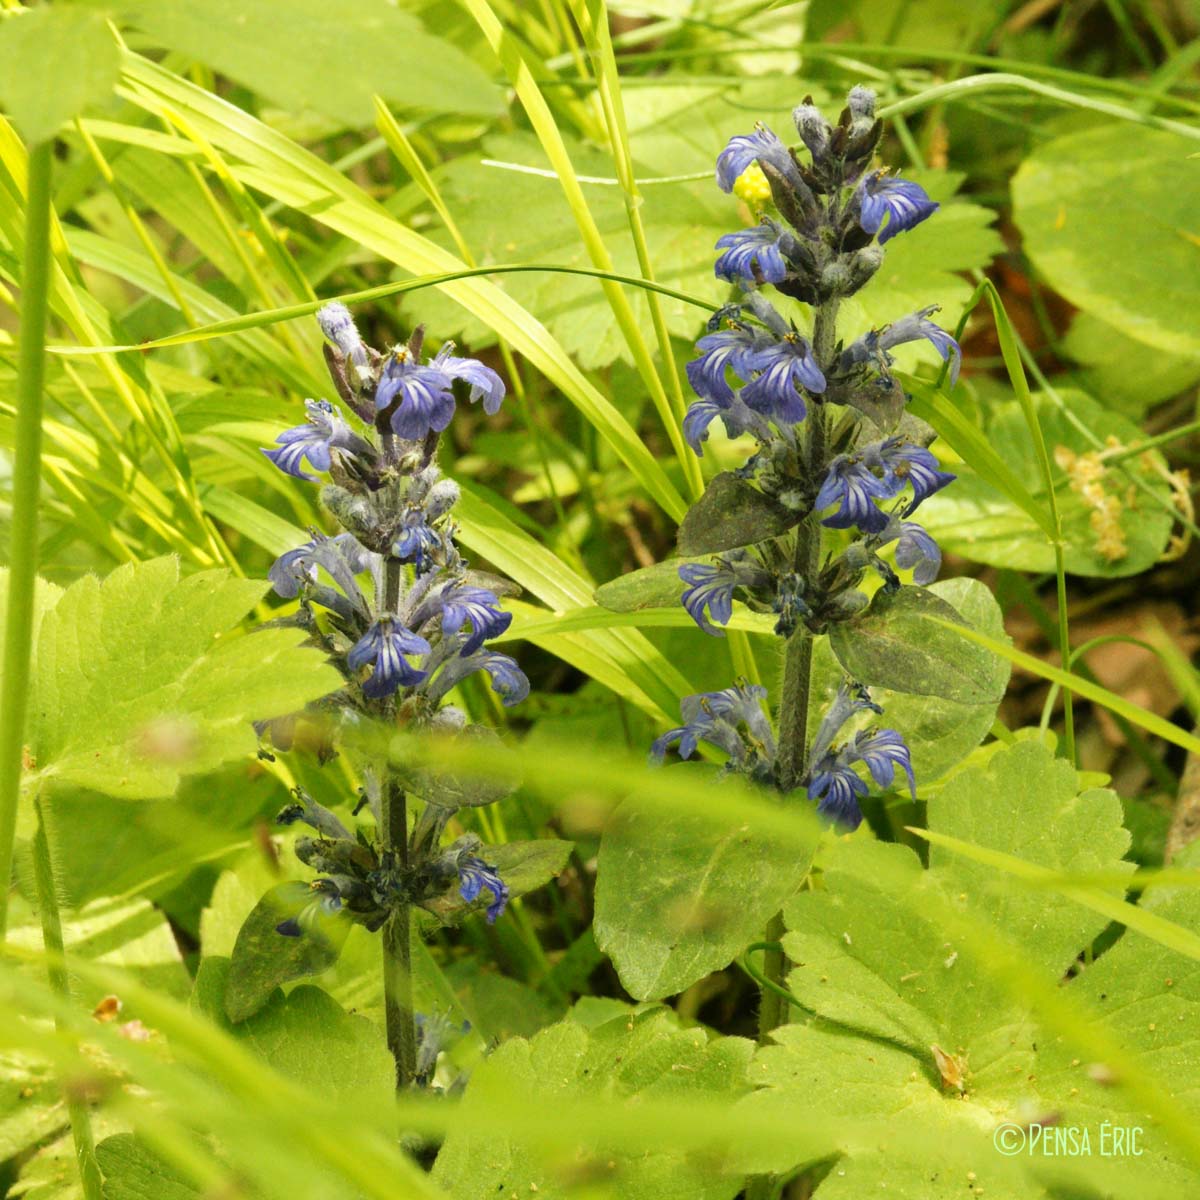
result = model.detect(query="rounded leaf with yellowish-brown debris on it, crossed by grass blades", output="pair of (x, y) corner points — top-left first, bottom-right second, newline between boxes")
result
(920, 389), (1172, 577)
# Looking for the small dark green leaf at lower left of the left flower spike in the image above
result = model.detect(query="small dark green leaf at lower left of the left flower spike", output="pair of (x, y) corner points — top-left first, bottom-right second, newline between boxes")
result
(224, 881), (350, 1024)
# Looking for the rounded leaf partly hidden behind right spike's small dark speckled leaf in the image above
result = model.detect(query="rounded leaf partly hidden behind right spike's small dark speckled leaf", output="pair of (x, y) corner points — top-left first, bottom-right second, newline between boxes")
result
(809, 578), (1010, 794)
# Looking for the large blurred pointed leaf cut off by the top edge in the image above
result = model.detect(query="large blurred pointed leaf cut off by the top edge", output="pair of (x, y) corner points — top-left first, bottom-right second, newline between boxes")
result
(99, 0), (503, 127)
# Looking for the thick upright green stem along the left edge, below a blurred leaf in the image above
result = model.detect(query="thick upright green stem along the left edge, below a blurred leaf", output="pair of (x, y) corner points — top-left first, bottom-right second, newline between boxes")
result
(0, 142), (54, 942)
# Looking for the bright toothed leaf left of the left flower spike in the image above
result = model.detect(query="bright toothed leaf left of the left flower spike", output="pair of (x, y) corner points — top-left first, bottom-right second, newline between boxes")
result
(31, 558), (342, 799)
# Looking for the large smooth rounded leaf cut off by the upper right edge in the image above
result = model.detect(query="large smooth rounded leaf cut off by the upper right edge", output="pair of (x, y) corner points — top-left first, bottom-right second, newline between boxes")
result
(1013, 124), (1200, 358)
